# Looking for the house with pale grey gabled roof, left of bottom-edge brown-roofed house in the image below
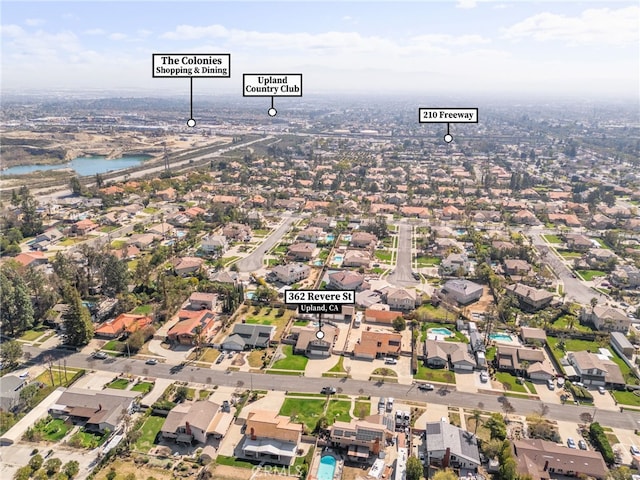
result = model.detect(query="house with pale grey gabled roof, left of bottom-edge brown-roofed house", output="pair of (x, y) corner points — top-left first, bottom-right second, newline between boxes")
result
(423, 420), (480, 472)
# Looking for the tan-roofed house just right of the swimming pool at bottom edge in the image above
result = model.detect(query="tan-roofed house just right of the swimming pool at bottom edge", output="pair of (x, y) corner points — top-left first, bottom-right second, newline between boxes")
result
(329, 415), (395, 462)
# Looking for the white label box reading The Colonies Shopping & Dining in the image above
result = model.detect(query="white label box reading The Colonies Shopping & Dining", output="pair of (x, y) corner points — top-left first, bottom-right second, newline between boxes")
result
(151, 53), (231, 78)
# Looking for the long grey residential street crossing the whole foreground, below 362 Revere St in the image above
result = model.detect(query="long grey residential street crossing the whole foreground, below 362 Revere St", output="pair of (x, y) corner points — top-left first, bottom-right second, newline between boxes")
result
(24, 346), (640, 430)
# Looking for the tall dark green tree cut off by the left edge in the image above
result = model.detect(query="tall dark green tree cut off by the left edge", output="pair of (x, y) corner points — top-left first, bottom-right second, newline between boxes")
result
(0, 263), (33, 336)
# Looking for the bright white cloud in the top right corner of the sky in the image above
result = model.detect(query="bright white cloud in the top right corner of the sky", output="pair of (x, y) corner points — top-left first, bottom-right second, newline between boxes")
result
(504, 6), (640, 46)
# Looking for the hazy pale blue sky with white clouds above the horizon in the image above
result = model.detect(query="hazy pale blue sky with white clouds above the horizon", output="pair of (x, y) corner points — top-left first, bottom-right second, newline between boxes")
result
(0, 0), (640, 98)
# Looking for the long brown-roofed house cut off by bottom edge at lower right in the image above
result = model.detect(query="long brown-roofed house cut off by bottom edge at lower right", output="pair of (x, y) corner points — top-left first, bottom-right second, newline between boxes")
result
(511, 439), (609, 480)
